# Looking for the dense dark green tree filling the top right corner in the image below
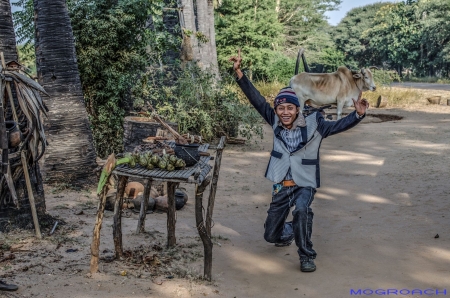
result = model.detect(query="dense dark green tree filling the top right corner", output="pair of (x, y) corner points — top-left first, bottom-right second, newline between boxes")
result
(334, 0), (450, 77)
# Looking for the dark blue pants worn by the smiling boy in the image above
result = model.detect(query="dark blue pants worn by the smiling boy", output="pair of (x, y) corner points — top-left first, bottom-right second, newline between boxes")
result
(264, 184), (317, 261)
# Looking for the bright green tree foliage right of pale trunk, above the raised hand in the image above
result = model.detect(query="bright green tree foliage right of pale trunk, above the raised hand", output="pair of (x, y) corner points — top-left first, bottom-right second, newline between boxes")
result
(216, 0), (284, 79)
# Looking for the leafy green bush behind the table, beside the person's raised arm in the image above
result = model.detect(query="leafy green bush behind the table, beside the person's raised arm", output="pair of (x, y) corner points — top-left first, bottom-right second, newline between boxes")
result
(135, 65), (262, 141)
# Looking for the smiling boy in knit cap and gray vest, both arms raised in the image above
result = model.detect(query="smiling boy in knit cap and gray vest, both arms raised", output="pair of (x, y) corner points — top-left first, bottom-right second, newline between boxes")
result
(230, 49), (369, 272)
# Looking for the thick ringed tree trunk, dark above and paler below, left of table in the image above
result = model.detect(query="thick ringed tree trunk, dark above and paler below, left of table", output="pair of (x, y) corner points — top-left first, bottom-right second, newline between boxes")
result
(34, 0), (96, 185)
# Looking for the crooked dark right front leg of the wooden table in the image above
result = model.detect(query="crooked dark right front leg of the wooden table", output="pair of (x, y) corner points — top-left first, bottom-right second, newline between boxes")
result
(195, 176), (213, 281)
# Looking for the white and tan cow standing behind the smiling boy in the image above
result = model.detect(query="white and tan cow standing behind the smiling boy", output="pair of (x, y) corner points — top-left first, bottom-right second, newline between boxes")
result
(290, 66), (376, 119)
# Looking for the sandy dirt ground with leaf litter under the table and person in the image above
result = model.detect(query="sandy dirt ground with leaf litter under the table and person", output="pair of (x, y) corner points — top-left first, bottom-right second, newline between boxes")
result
(0, 99), (450, 298)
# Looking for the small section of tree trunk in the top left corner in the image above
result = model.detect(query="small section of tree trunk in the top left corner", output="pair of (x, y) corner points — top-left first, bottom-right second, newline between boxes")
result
(0, 0), (18, 62)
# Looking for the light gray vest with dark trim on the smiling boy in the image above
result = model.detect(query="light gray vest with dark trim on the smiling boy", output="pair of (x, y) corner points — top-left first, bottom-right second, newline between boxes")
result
(266, 113), (322, 188)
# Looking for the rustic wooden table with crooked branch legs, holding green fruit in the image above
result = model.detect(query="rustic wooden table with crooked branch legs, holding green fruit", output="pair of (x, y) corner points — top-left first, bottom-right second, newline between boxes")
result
(91, 137), (225, 280)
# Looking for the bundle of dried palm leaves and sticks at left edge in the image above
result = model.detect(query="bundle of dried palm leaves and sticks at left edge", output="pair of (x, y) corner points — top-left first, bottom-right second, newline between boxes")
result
(0, 53), (48, 231)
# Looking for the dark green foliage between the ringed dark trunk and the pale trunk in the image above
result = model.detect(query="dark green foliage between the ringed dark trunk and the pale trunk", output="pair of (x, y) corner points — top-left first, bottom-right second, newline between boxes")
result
(71, 0), (168, 156)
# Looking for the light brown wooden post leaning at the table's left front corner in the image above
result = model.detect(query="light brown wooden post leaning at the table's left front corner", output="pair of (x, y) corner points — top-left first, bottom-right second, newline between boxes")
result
(90, 153), (116, 273)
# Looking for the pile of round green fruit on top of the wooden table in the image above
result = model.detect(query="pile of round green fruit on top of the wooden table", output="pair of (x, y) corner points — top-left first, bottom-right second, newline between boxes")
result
(121, 151), (186, 171)
